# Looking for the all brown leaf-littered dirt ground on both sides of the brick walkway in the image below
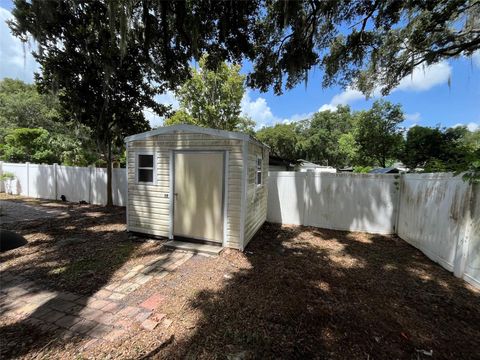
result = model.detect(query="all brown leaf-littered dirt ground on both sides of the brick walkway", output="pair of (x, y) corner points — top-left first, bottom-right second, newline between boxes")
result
(0, 195), (480, 359)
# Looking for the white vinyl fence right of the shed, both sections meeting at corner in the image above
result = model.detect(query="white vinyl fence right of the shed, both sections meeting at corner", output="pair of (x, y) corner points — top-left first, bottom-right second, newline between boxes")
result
(267, 171), (480, 287)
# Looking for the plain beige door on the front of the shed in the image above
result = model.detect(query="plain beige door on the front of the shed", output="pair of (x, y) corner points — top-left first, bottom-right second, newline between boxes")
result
(173, 152), (224, 243)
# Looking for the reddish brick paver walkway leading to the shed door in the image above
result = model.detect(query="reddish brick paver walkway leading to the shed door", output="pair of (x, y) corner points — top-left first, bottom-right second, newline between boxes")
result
(0, 251), (192, 346)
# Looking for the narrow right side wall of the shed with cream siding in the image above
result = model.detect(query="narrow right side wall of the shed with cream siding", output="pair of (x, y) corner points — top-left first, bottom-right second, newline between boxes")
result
(244, 142), (268, 247)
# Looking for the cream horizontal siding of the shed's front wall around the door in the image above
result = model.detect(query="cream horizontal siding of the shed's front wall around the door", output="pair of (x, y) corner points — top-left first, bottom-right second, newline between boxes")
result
(128, 133), (243, 249)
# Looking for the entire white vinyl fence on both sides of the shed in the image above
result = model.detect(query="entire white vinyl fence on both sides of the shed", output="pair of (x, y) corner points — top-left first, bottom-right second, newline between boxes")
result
(0, 162), (480, 287)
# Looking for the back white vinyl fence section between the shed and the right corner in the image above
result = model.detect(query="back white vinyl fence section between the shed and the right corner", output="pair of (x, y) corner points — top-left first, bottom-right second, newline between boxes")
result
(267, 171), (400, 234)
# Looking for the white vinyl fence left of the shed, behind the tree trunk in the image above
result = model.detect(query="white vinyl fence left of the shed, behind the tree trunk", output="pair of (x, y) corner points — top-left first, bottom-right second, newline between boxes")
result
(0, 163), (127, 206)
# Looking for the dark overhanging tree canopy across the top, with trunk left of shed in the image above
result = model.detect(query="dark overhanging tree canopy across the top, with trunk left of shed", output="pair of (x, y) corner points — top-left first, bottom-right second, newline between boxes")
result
(10, 0), (480, 203)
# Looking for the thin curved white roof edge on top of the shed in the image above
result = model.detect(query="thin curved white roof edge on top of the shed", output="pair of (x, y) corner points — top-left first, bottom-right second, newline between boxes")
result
(125, 124), (268, 148)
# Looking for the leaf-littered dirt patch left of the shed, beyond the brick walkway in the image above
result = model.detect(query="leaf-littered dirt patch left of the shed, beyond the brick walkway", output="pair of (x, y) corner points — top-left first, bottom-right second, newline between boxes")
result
(0, 197), (163, 294)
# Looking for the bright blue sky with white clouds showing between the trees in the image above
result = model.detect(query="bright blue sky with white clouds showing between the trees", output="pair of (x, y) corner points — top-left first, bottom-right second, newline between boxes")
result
(0, 0), (480, 130)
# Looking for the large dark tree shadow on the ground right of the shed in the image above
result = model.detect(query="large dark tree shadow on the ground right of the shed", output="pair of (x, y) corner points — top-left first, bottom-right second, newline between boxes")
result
(153, 224), (480, 359)
